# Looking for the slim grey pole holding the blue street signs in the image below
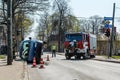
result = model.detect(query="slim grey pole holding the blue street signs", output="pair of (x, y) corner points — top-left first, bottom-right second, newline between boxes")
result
(109, 3), (115, 57)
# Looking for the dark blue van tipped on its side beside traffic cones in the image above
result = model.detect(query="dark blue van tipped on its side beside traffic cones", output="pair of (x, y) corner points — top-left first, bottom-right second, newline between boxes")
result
(19, 40), (43, 63)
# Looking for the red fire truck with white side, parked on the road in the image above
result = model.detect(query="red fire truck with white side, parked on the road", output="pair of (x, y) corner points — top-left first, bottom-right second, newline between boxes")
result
(64, 32), (97, 59)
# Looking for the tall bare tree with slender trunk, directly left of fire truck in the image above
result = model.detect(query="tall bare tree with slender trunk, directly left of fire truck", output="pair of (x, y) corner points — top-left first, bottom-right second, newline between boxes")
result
(53, 0), (69, 51)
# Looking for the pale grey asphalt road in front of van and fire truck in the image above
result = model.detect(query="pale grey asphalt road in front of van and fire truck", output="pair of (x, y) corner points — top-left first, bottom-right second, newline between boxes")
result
(28, 52), (120, 80)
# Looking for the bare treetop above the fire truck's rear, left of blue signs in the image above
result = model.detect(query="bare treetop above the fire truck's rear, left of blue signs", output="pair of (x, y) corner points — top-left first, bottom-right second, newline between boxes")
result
(80, 15), (103, 34)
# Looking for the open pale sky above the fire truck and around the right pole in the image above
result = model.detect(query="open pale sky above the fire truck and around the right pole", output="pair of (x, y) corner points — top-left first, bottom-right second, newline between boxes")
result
(69, 0), (120, 32)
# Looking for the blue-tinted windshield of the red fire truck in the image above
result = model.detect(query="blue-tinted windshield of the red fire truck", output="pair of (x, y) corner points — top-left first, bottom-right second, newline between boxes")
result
(65, 34), (82, 41)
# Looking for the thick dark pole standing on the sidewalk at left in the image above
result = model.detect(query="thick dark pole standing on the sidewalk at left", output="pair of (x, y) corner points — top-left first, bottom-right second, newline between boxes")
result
(7, 0), (13, 65)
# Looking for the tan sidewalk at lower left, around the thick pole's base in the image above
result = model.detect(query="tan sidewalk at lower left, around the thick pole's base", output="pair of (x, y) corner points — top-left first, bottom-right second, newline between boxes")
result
(0, 58), (28, 80)
